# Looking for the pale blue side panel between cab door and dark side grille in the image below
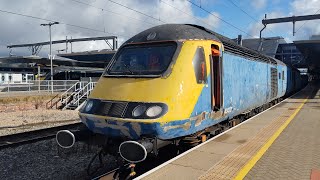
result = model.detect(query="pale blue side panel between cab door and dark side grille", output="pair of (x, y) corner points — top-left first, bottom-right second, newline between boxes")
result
(223, 53), (270, 115)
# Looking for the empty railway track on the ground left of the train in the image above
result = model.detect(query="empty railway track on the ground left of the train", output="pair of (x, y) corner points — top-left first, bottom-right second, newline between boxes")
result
(0, 122), (84, 150)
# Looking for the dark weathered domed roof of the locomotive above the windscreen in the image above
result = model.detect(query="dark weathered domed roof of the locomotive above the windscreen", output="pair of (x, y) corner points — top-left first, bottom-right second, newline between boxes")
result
(123, 24), (277, 64)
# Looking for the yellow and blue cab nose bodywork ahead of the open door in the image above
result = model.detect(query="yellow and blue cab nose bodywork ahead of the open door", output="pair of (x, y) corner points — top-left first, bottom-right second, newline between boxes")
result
(80, 41), (230, 139)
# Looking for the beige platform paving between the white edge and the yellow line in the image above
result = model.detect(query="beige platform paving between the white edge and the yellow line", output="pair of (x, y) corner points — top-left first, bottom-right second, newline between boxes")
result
(137, 86), (310, 180)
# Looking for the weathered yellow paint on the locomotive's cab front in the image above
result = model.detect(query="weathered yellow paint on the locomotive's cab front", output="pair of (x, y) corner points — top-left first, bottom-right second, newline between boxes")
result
(90, 40), (221, 123)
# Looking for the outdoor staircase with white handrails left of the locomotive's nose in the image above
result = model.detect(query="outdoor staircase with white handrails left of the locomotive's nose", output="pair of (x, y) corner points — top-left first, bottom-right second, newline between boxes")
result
(46, 81), (96, 110)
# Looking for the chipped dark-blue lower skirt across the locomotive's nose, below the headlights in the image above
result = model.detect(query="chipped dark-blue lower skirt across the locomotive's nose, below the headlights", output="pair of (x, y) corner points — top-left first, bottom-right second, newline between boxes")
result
(80, 114), (226, 140)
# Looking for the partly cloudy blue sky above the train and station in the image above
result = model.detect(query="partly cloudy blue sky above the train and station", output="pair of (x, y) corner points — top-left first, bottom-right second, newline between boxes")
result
(0, 0), (320, 57)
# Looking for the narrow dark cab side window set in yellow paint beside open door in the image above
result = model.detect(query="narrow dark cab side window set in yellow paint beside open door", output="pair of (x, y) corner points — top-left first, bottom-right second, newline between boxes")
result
(192, 46), (207, 84)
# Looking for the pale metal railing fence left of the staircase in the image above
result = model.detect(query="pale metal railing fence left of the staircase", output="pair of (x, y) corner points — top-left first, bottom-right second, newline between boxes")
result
(0, 80), (79, 92)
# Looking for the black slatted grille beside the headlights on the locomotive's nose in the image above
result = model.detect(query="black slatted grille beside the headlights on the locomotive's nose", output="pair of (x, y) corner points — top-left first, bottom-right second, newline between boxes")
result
(96, 102), (128, 117)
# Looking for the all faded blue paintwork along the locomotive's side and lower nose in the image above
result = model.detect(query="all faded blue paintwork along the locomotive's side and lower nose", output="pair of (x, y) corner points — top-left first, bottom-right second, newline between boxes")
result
(80, 53), (296, 140)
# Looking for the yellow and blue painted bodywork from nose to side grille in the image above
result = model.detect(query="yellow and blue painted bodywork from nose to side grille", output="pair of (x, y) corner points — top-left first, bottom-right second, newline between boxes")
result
(80, 41), (284, 139)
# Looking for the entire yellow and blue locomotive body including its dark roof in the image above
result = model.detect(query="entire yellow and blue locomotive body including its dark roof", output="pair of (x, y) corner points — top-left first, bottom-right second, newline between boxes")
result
(80, 25), (301, 140)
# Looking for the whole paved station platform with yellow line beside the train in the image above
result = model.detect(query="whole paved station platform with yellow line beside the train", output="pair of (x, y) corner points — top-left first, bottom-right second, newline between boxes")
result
(136, 82), (320, 180)
